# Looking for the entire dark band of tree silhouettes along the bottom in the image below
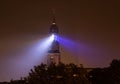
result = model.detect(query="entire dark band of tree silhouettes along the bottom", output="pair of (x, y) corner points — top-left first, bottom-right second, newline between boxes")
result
(0, 60), (120, 84)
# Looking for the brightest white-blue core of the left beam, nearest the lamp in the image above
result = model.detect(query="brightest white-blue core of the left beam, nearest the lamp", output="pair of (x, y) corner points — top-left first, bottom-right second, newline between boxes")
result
(24, 34), (55, 60)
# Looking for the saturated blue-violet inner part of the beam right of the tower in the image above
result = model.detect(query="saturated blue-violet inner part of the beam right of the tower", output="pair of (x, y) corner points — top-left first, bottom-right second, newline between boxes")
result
(59, 36), (88, 54)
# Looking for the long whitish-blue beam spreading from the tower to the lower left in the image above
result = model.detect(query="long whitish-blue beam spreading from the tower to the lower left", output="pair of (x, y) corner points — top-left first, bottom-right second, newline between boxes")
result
(1, 35), (54, 80)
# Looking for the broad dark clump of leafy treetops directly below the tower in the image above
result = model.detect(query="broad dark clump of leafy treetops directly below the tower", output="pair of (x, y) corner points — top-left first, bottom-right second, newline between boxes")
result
(27, 63), (89, 84)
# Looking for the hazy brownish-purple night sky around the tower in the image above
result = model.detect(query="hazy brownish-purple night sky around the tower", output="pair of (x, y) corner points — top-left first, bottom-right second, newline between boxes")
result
(0, 0), (120, 81)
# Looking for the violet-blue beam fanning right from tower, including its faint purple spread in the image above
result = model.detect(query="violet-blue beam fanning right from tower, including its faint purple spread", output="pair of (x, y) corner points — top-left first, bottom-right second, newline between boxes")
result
(59, 36), (96, 64)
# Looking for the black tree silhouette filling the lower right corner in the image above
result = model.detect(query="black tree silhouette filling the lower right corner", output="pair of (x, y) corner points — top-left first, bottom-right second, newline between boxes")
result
(88, 59), (120, 84)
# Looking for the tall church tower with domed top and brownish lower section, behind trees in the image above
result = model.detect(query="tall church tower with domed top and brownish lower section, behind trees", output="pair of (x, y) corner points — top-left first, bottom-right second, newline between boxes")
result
(47, 14), (60, 65)
